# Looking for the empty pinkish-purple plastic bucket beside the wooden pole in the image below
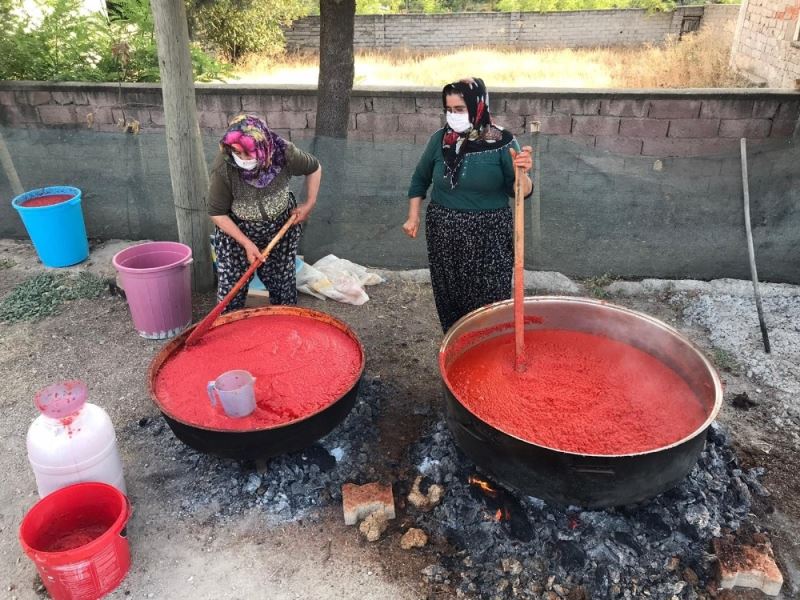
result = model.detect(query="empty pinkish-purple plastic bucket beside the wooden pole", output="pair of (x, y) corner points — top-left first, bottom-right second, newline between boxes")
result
(113, 242), (192, 340)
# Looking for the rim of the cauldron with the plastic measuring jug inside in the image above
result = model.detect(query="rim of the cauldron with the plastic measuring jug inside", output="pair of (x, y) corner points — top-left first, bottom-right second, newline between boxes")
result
(147, 305), (366, 435)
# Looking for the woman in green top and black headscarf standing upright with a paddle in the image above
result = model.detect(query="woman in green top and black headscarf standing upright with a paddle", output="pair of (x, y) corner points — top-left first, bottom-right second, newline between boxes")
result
(403, 78), (533, 332)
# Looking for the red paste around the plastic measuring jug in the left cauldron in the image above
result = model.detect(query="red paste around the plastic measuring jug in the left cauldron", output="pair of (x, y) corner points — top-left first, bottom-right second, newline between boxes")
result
(155, 315), (363, 431)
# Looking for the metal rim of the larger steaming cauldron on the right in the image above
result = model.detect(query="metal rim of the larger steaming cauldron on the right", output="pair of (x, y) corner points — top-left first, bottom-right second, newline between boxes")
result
(438, 296), (722, 459)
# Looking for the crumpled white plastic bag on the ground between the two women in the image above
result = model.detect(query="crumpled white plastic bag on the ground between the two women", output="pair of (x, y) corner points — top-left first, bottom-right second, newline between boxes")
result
(297, 254), (383, 306)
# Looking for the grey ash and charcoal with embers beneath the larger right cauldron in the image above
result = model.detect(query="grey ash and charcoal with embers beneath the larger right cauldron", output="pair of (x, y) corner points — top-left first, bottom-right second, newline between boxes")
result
(411, 421), (767, 600)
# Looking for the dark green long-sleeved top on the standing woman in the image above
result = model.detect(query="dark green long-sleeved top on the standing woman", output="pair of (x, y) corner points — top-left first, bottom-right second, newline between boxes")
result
(408, 129), (519, 211)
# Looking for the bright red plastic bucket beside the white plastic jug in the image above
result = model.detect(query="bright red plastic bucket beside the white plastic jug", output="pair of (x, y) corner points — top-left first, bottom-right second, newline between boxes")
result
(19, 482), (131, 600)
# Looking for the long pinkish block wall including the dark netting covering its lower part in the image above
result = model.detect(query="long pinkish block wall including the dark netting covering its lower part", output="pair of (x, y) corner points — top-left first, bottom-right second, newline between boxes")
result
(0, 82), (800, 283)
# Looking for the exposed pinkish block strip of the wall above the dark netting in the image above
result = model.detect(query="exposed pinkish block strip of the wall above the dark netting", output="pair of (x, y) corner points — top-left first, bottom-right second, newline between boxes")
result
(0, 82), (800, 157)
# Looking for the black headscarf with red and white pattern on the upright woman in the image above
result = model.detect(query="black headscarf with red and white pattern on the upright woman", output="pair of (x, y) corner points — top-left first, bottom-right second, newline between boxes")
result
(442, 77), (511, 188)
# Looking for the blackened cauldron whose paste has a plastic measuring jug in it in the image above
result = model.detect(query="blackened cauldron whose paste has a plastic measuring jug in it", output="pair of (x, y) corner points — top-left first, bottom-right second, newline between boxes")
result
(148, 306), (364, 459)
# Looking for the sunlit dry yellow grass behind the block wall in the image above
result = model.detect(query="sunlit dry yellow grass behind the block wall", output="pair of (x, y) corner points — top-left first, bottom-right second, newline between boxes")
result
(235, 25), (747, 88)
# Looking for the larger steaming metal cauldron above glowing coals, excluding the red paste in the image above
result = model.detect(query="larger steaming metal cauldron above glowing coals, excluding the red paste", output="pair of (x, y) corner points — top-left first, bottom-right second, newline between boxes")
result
(439, 296), (722, 507)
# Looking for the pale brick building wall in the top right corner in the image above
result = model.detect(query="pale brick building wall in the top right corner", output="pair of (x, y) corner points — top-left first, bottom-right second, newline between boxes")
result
(731, 0), (800, 89)
